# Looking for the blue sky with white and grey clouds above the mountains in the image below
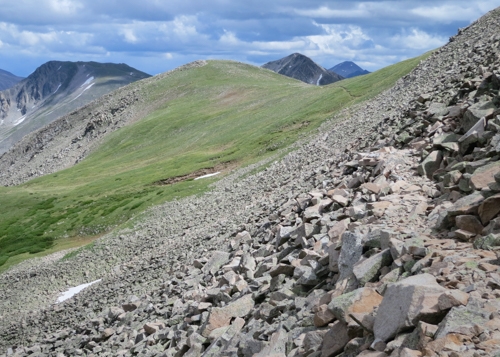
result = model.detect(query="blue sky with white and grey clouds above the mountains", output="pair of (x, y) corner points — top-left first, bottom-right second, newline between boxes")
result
(0, 0), (500, 77)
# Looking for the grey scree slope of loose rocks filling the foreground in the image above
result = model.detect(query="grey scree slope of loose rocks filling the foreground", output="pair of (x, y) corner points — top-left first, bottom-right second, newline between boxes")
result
(0, 6), (500, 357)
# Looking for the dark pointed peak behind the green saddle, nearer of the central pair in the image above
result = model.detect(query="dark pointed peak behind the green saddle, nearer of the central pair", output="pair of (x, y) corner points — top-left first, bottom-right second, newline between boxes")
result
(262, 53), (344, 86)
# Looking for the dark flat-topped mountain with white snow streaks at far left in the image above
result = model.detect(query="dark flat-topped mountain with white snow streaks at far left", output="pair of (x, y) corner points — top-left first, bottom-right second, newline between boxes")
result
(0, 61), (150, 153)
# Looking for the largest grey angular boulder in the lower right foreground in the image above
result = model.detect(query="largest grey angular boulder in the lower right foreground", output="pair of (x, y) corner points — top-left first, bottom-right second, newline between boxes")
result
(374, 273), (447, 341)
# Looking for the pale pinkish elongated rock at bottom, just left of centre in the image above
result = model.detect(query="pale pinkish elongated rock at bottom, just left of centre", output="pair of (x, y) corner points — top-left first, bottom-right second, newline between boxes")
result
(202, 295), (255, 337)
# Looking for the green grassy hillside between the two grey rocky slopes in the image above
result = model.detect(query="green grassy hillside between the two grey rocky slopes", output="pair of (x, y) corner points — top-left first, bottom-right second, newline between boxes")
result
(0, 53), (430, 270)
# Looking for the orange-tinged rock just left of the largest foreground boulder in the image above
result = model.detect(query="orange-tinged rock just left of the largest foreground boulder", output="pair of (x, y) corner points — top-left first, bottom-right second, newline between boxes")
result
(328, 287), (382, 324)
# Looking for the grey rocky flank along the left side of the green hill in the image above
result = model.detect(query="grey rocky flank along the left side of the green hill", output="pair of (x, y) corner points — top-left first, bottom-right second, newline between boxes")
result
(0, 61), (206, 186)
